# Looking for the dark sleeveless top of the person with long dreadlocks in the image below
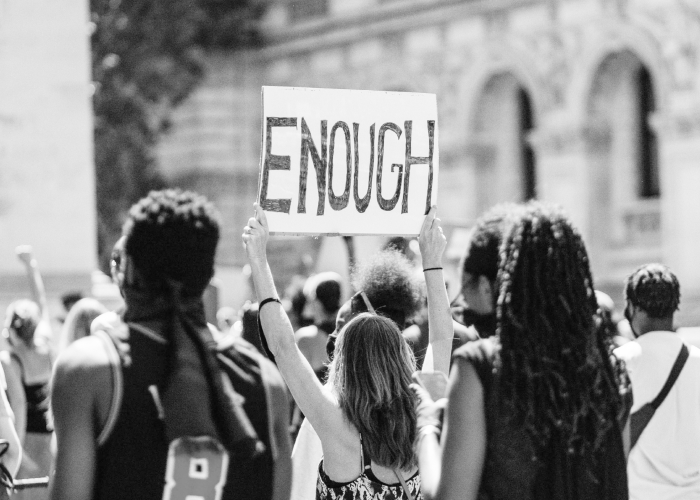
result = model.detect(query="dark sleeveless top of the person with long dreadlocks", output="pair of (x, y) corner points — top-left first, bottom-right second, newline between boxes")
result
(453, 338), (628, 500)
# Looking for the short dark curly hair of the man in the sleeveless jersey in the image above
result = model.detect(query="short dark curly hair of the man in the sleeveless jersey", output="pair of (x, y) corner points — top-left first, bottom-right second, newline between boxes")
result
(123, 189), (219, 294)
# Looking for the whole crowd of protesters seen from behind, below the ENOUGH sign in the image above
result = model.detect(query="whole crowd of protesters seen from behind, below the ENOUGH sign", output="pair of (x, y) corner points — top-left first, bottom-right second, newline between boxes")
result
(0, 190), (700, 500)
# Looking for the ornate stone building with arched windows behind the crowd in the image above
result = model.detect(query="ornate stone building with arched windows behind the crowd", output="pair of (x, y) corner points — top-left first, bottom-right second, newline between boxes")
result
(160, 0), (700, 324)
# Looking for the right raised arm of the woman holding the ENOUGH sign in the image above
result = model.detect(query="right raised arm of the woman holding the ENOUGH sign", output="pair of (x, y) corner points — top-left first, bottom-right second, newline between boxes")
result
(418, 206), (454, 374)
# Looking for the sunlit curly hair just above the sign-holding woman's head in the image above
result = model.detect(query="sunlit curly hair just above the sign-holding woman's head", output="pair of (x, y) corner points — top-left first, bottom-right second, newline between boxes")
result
(352, 249), (421, 329)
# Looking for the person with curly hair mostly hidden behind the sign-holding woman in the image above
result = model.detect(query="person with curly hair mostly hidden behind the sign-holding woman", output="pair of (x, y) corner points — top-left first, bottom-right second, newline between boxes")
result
(292, 248), (427, 500)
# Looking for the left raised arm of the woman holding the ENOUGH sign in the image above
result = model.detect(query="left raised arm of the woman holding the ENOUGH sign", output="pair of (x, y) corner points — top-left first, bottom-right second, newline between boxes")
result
(243, 203), (343, 439)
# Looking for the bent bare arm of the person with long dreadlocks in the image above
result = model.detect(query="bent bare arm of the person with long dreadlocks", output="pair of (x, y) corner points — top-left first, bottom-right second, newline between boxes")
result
(416, 360), (486, 500)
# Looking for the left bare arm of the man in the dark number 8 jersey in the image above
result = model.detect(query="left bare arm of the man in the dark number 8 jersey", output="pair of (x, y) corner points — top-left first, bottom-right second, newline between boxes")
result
(51, 338), (102, 500)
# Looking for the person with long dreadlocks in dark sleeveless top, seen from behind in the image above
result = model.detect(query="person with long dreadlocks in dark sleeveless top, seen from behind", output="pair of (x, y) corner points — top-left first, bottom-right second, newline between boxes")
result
(413, 202), (628, 500)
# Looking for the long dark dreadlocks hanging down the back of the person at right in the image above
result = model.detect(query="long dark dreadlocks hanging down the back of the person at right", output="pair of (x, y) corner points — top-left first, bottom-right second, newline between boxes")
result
(497, 202), (621, 455)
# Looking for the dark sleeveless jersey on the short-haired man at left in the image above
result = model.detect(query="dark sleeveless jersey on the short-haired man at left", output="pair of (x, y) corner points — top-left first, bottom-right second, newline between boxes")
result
(93, 323), (275, 500)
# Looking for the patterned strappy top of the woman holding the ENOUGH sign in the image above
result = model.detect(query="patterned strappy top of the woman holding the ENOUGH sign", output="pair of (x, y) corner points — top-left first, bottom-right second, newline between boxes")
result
(316, 436), (423, 500)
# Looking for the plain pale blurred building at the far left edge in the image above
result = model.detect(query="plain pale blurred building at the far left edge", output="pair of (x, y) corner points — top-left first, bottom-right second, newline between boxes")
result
(0, 0), (97, 317)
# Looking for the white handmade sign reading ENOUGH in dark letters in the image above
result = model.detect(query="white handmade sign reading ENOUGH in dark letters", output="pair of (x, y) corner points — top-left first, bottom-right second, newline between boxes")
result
(258, 87), (439, 236)
